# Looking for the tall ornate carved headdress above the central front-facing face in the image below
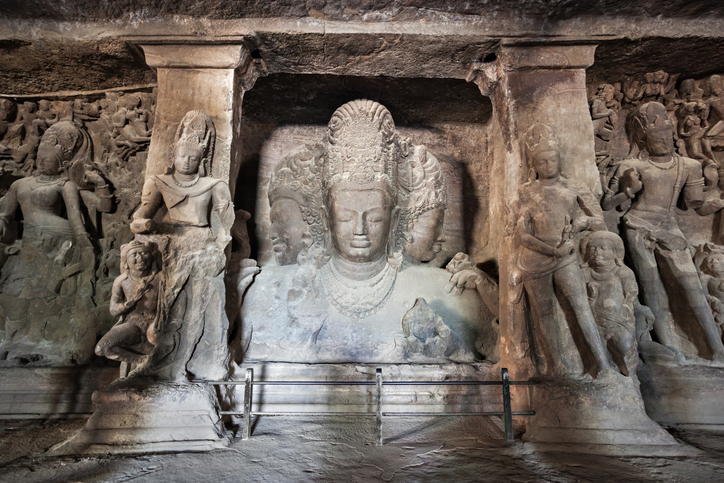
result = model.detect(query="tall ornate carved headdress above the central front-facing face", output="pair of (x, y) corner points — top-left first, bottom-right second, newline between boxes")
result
(323, 99), (400, 200)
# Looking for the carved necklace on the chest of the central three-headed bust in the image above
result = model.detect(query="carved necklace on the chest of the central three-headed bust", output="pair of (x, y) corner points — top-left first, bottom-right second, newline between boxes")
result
(321, 260), (397, 319)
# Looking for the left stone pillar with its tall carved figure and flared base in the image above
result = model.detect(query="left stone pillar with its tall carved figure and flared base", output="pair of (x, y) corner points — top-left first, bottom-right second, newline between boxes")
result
(55, 44), (264, 453)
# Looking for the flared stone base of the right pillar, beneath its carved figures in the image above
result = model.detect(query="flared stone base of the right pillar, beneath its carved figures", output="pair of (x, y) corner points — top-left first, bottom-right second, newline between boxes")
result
(523, 375), (679, 451)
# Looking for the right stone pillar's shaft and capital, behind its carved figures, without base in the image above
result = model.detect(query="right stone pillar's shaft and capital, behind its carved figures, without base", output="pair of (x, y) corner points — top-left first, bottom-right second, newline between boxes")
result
(468, 45), (601, 379)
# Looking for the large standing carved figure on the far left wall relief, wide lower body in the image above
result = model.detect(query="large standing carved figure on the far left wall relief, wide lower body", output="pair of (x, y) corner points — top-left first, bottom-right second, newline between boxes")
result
(0, 121), (112, 364)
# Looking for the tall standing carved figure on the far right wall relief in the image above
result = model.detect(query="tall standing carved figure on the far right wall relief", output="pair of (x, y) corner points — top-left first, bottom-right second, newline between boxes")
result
(602, 102), (724, 361)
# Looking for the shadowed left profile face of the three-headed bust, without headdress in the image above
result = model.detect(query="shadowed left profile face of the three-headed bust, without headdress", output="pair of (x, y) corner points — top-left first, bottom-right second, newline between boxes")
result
(269, 198), (307, 265)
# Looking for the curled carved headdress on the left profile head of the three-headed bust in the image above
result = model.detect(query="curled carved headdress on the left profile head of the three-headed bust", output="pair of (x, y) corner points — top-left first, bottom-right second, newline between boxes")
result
(269, 144), (324, 243)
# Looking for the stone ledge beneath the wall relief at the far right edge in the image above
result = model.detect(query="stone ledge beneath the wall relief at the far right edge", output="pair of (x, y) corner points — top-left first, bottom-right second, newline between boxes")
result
(638, 362), (724, 431)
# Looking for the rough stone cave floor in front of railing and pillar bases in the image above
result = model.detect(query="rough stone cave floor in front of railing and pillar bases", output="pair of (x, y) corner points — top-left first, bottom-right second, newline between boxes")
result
(0, 417), (724, 483)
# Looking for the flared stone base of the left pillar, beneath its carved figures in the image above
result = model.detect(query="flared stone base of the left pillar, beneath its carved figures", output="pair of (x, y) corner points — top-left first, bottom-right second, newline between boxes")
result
(51, 379), (230, 454)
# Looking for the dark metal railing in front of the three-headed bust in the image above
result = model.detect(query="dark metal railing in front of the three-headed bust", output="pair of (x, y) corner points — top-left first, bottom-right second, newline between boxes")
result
(205, 368), (535, 444)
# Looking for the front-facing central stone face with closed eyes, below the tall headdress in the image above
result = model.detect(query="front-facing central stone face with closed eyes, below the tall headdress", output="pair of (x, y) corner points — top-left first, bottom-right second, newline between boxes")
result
(327, 183), (393, 263)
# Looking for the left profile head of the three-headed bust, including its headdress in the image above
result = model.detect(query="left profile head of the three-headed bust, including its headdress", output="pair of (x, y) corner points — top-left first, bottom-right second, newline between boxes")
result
(269, 144), (324, 265)
